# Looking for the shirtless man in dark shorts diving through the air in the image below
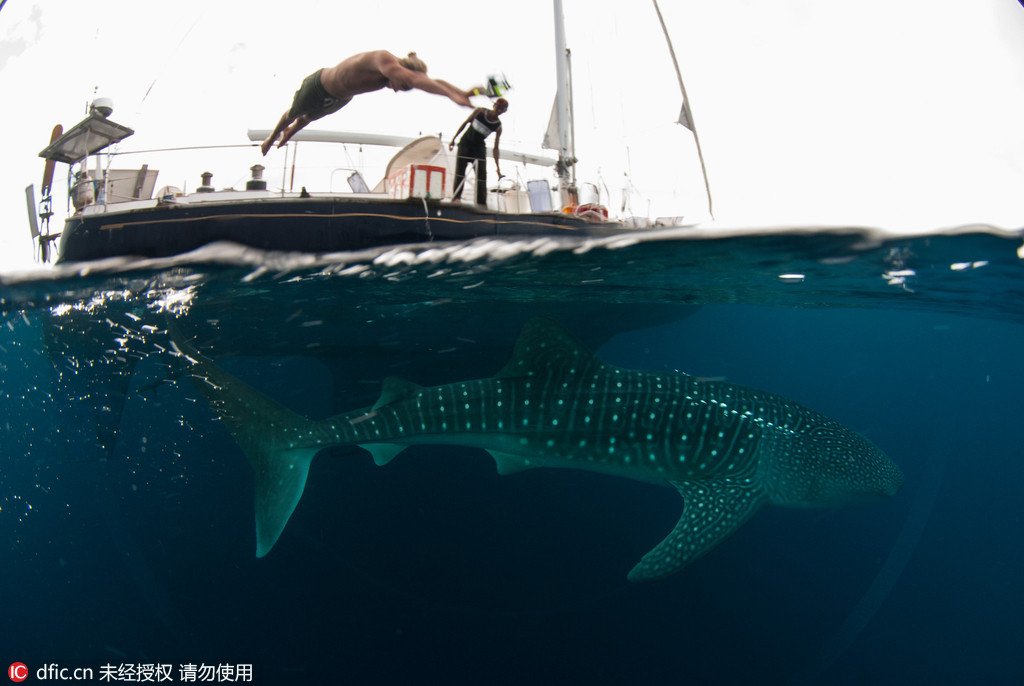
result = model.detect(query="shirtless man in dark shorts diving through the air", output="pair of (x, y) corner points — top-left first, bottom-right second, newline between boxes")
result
(260, 50), (472, 155)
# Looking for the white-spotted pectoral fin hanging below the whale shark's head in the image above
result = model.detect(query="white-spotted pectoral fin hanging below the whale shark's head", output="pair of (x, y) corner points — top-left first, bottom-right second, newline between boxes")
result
(629, 478), (764, 582)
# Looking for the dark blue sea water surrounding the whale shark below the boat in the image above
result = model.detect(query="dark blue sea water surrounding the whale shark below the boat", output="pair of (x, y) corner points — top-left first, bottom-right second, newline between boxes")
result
(0, 229), (1024, 684)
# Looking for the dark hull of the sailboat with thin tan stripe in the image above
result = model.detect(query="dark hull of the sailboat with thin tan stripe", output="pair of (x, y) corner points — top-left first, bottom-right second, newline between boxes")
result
(57, 198), (622, 262)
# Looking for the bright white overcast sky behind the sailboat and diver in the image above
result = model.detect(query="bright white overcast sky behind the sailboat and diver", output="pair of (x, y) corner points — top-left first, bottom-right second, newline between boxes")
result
(0, 0), (1024, 270)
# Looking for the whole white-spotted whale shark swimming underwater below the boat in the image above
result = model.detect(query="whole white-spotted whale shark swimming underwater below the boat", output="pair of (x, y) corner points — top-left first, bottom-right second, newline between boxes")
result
(171, 318), (903, 582)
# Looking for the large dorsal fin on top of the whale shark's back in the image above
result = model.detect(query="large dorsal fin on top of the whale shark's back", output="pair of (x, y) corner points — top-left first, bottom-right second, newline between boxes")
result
(495, 317), (605, 379)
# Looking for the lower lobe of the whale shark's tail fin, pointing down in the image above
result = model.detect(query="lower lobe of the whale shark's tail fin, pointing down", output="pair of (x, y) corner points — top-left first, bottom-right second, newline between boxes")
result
(252, 447), (319, 557)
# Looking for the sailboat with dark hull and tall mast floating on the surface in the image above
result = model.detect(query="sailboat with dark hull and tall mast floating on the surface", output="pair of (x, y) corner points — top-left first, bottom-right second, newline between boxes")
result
(26, 0), (710, 262)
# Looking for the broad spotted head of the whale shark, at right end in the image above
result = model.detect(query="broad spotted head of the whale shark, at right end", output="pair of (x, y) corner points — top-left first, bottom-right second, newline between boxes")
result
(764, 415), (903, 507)
